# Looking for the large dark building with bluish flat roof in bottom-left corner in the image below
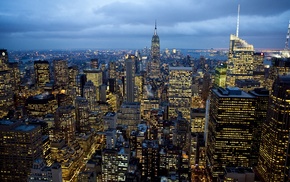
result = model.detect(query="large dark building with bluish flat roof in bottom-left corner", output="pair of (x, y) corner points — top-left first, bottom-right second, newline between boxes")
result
(0, 120), (42, 181)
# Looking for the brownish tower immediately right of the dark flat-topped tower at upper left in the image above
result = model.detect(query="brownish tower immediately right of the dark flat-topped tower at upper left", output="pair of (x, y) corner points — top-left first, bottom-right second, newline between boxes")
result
(53, 60), (69, 89)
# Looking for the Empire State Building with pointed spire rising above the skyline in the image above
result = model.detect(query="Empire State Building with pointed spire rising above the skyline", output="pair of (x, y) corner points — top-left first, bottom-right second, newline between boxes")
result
(149, 23), (160, 78)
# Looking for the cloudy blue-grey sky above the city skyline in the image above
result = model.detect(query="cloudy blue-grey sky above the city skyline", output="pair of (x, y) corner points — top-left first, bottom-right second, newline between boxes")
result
(0, 0), (290, 50)
